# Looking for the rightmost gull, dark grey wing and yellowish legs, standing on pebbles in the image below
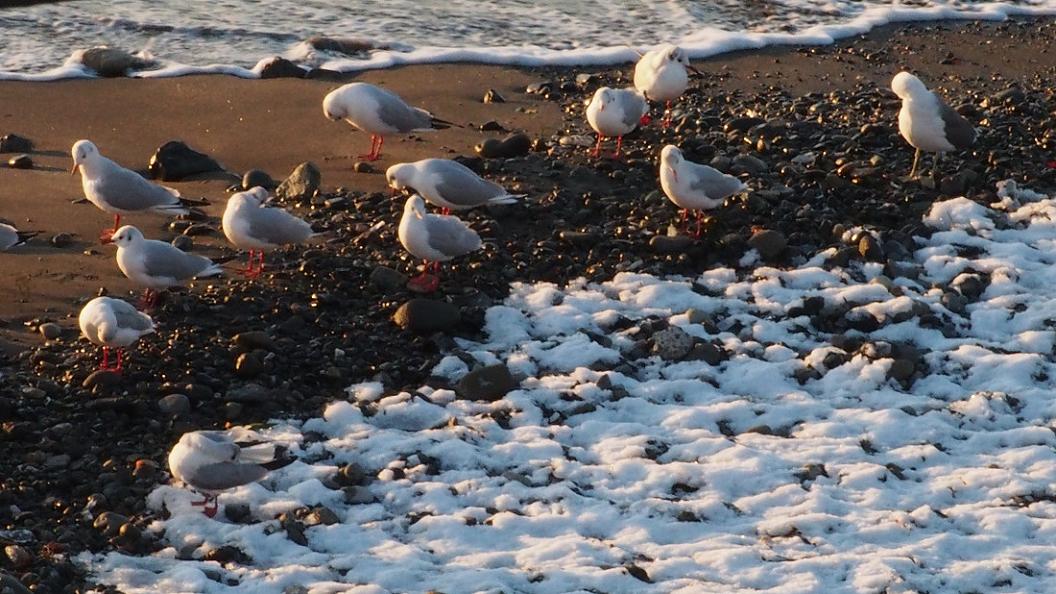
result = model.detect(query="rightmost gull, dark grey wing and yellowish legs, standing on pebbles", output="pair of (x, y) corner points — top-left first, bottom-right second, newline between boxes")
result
(891, 72), (976, 178)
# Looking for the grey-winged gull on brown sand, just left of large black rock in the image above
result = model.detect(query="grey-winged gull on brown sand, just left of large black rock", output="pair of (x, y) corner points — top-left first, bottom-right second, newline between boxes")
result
(70, 141), (187, 243)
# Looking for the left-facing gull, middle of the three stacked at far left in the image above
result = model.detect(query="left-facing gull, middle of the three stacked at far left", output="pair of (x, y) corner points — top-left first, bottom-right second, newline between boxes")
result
(113, 225), (224, 309)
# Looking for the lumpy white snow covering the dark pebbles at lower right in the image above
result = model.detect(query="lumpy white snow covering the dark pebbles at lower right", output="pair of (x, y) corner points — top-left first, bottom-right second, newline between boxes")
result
(79, 186), (1056, 594)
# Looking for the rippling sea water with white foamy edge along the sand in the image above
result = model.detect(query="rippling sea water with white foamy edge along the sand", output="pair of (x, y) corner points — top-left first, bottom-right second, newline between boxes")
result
(0, 0), (1056, 79)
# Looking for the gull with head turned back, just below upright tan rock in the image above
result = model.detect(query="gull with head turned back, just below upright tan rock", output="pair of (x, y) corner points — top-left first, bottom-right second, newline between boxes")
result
(223, 186), (317, 277)
